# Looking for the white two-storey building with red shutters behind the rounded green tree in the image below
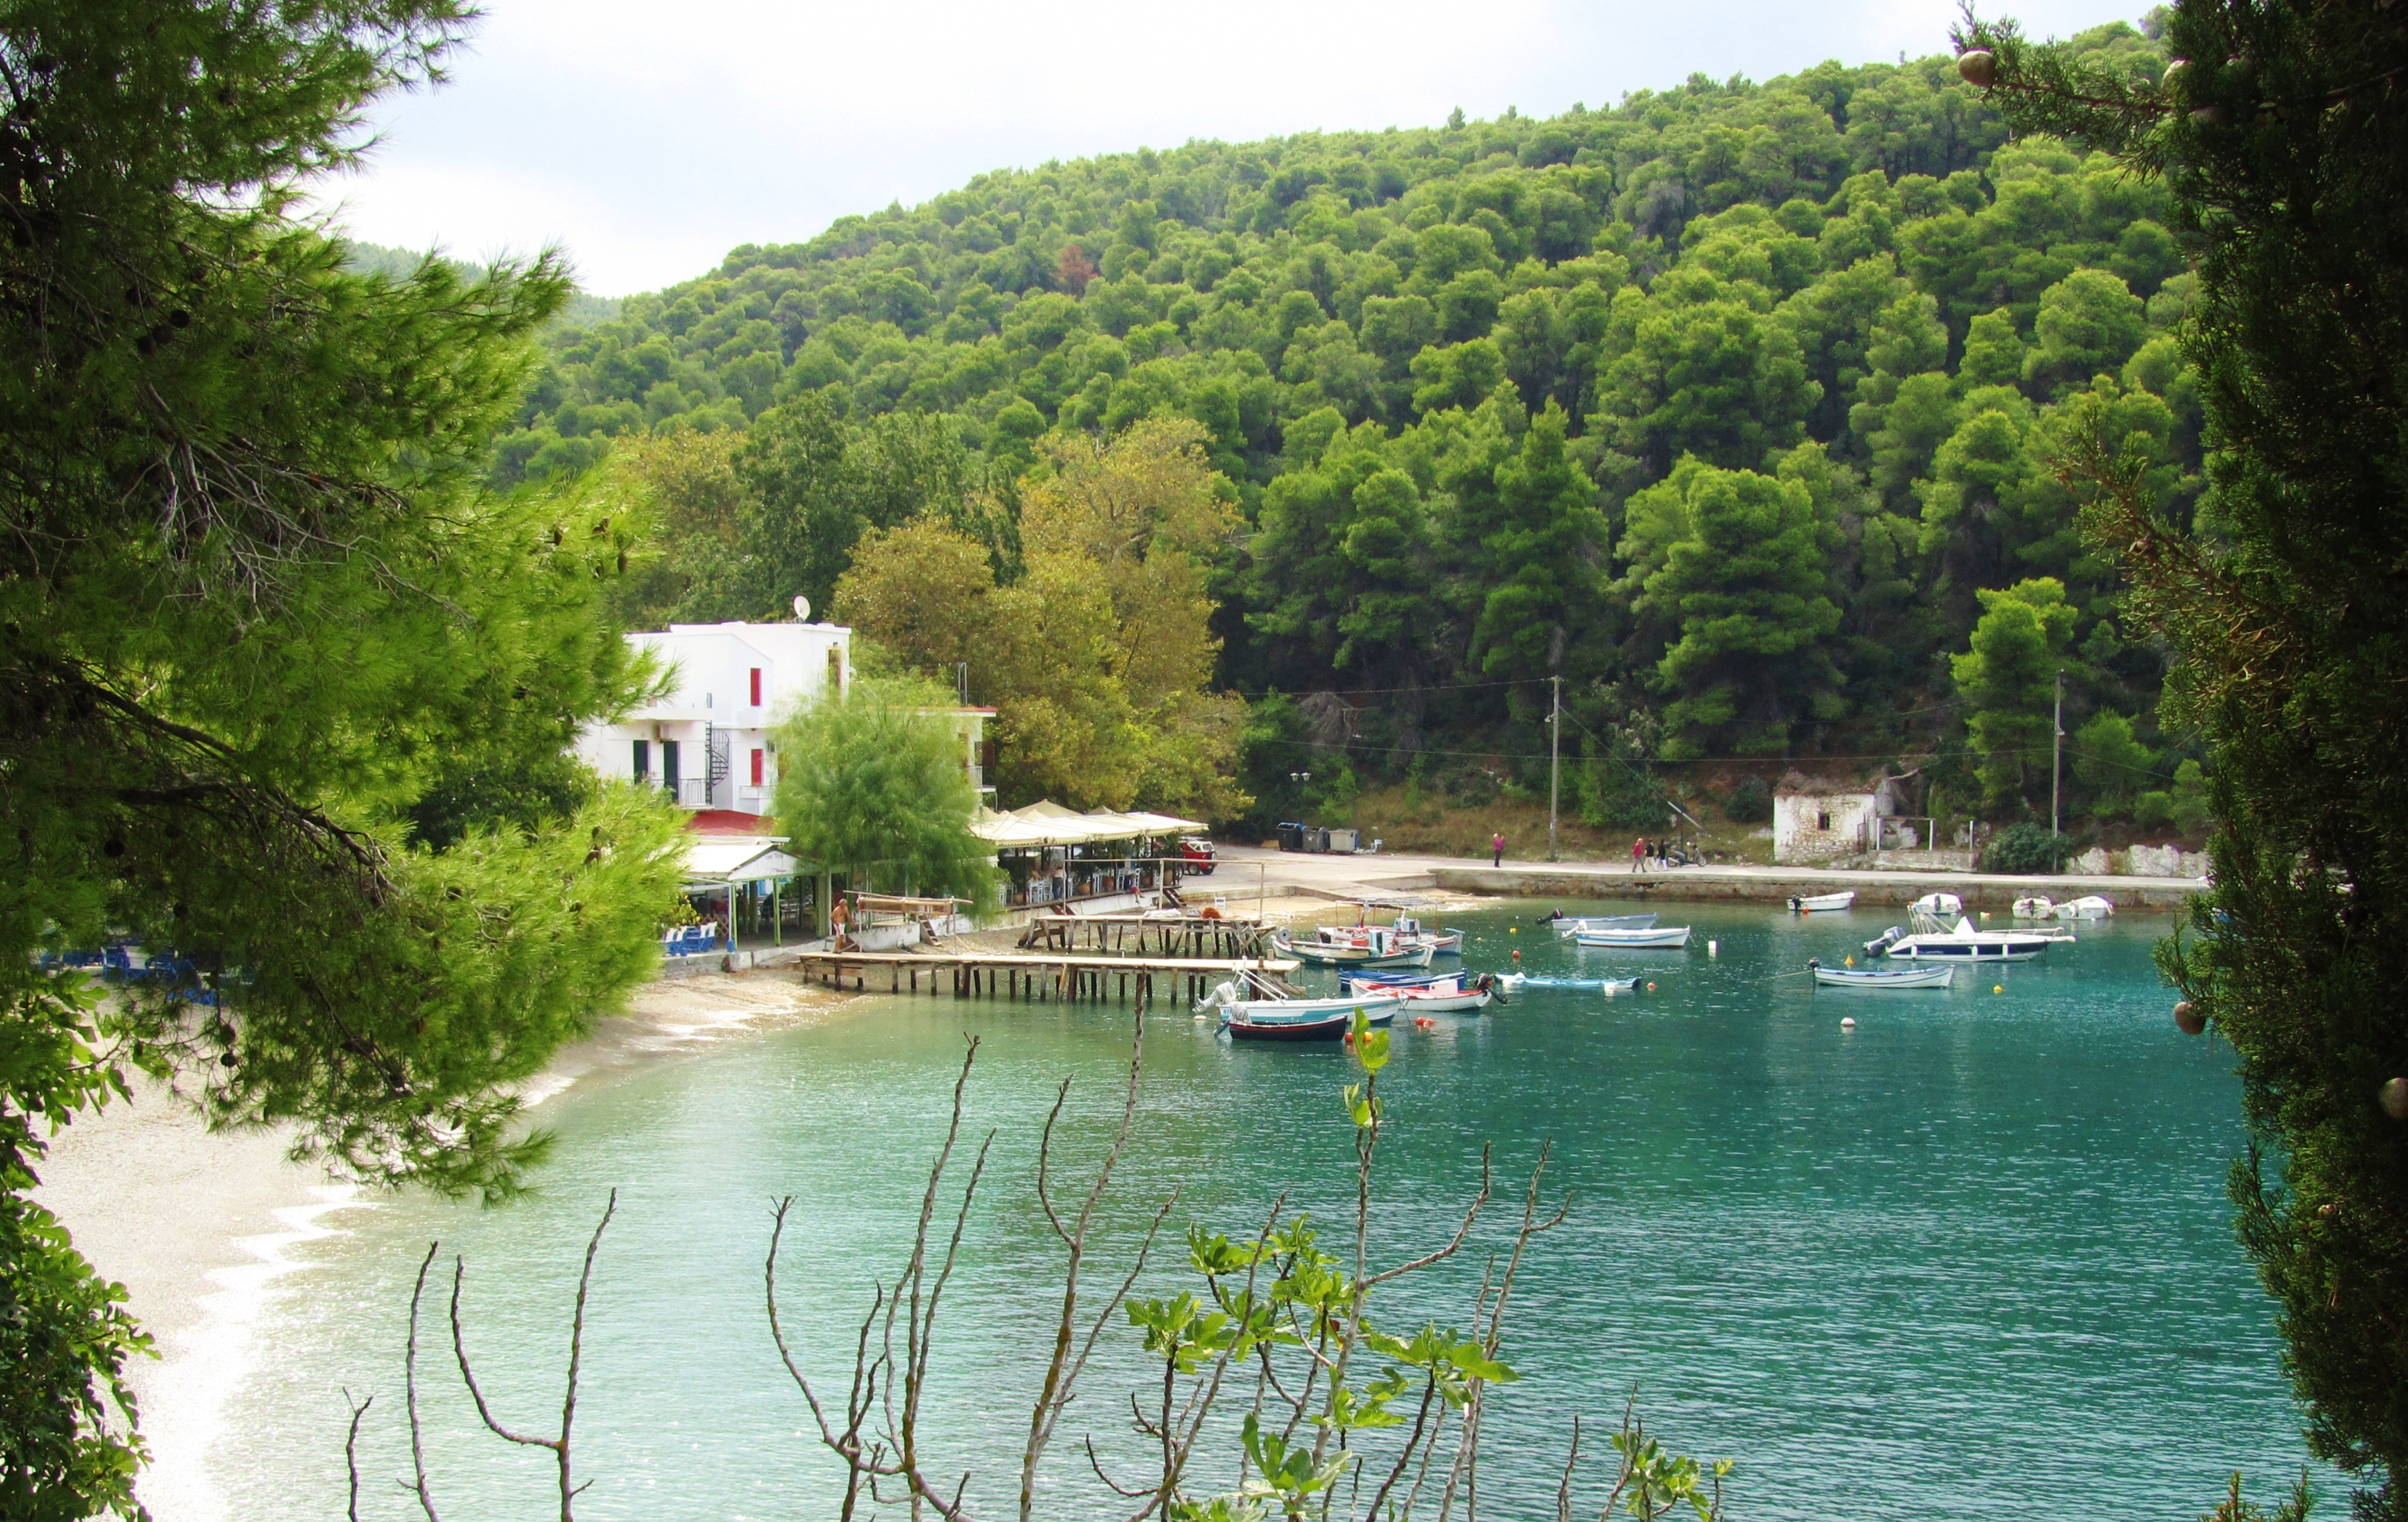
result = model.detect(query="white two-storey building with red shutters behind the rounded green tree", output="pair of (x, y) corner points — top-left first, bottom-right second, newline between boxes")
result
(573, 621), (994, 814)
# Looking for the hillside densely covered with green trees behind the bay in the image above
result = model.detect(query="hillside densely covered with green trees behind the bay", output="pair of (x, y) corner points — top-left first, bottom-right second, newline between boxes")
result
(496, 24), (2201, 826)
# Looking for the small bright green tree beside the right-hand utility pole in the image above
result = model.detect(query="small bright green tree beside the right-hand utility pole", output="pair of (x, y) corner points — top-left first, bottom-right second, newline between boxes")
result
(1950, 575), (2073, 809)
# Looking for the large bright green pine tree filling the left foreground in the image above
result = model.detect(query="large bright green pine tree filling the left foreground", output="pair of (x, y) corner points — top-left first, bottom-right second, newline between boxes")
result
(0, 0), (679, 1517)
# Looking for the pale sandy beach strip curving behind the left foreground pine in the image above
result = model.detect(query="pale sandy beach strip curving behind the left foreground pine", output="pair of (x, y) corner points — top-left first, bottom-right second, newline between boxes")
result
(36, 971), (853, 1522)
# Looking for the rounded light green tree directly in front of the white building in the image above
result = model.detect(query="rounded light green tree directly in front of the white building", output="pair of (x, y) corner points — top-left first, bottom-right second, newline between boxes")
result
(775, 677), (994, 905)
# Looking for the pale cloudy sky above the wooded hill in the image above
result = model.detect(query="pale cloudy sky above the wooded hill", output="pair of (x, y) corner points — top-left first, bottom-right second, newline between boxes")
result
(320, 0), (2136, 296)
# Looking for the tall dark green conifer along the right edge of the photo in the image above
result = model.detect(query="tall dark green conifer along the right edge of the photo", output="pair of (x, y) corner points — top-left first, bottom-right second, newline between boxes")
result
(1960, 0), (2408, 1517)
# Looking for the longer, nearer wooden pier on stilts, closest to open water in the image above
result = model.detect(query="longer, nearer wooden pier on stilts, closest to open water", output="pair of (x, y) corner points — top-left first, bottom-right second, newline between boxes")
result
(794, 951), (1300, 1004)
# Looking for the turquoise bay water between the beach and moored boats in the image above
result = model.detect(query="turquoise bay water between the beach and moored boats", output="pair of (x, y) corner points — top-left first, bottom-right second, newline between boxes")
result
(214, 905), (2302, 1522)
